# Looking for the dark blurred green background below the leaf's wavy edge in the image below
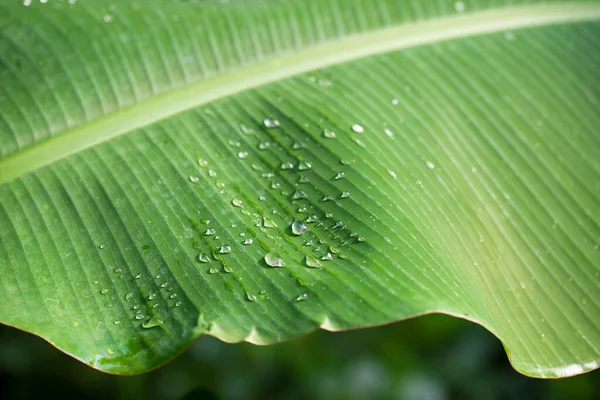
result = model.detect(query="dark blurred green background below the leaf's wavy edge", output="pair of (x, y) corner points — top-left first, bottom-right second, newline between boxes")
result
(0, 315), (600, 400)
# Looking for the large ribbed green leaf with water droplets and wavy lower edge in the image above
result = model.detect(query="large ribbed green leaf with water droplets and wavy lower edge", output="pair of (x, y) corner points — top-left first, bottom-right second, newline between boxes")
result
(0, 0), (600, 377)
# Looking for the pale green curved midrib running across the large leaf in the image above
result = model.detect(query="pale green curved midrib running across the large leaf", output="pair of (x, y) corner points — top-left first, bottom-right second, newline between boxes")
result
(0, 2), (600, 184)
